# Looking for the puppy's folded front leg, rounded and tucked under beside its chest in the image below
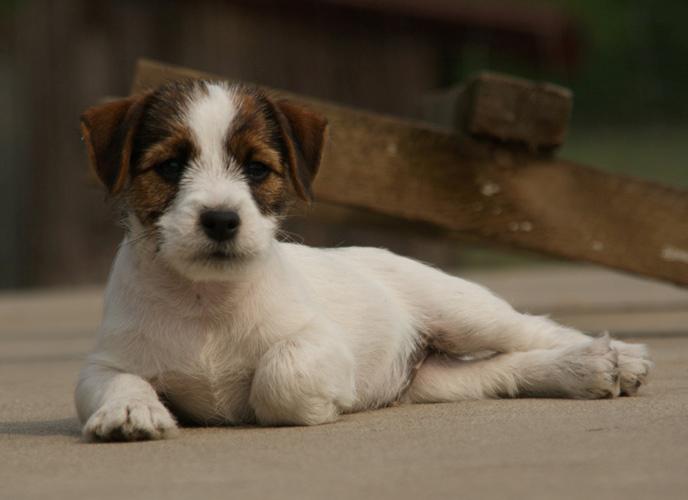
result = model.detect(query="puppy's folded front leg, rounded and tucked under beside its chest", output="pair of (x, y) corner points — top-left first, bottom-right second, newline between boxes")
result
(250, 327), (355, 425)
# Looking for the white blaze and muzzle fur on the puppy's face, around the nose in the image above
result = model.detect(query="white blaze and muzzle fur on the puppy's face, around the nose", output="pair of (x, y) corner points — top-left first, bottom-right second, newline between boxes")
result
(156, 84), (276, 280)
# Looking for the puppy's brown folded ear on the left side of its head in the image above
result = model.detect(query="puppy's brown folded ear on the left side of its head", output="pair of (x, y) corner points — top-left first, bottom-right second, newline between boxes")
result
(81, 94), (149, 194)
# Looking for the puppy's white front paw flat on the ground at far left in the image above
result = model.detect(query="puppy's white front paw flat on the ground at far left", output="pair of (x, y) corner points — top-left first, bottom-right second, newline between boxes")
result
(83, 399), (177, 441)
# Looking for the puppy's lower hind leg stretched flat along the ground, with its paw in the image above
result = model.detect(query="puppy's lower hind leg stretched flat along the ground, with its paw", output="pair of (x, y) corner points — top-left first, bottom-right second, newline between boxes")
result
(402, 336), (620, 403)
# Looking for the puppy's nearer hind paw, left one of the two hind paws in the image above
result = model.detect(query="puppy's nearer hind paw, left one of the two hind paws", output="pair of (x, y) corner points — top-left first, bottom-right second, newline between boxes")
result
(560, 335), (621, 399)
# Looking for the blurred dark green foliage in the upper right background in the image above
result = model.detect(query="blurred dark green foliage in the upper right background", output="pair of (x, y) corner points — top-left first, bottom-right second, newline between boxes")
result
(454, 0), (688, 125)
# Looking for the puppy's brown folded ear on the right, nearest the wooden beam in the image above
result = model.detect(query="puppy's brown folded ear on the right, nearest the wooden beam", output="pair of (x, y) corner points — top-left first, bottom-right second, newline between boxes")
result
(274, 100), (327, 201)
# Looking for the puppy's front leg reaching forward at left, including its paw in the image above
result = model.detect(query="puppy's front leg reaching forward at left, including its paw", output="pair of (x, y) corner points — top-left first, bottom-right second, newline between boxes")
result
(75, 364), (177, 441)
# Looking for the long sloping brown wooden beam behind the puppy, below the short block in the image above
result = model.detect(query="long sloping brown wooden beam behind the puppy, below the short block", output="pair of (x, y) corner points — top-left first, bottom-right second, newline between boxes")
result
(133, 61), (688, 285)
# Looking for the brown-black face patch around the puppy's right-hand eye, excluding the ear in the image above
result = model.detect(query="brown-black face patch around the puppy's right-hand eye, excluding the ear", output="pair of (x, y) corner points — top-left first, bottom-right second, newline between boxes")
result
(227, 87), (288, 215)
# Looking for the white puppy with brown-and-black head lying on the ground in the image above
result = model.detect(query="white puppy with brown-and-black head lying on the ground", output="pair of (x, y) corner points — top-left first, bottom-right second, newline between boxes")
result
(76, 81), (651, 440)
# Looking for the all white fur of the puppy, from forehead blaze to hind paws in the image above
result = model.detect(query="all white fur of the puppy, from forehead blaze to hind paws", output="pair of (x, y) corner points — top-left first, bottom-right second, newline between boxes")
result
(76, 83), (651, 439)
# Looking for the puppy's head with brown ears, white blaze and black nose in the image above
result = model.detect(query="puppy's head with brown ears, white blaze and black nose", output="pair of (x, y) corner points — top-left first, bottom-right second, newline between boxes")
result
(81, 81), (327, 280)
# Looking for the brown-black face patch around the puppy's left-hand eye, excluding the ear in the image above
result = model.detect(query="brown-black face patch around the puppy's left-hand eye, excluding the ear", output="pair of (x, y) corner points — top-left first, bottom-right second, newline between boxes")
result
(126, 81), (205, 225)
